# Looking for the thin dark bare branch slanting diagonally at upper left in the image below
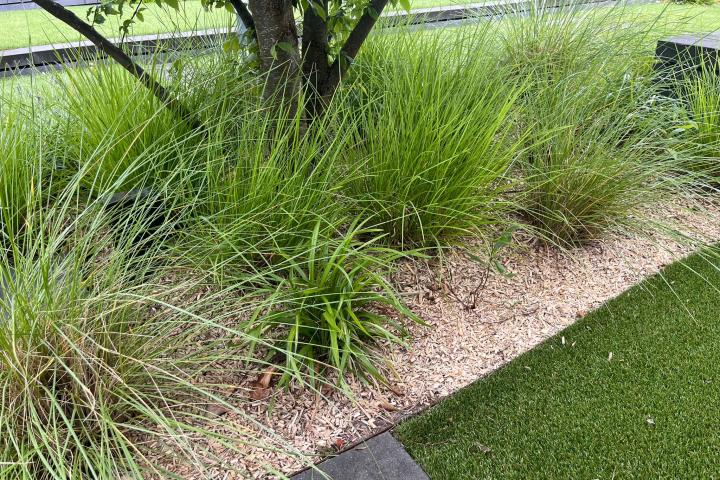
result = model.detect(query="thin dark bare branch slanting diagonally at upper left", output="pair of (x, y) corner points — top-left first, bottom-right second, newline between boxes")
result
(33, 0), (200, 128)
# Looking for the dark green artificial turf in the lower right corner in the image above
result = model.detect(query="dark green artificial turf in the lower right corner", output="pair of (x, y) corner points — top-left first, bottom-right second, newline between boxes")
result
(395, 249), (720, 480)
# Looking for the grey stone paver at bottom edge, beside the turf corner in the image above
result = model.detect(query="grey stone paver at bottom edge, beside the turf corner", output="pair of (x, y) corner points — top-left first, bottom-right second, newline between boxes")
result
(291, 432), (430, 480)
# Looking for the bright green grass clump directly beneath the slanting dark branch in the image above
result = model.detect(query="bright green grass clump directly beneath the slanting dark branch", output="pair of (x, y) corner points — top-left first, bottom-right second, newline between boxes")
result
(56, 62), (193, 194)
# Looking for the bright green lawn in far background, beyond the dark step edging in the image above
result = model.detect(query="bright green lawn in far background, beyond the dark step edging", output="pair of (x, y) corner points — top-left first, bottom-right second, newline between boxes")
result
(0, 0), (720, 50)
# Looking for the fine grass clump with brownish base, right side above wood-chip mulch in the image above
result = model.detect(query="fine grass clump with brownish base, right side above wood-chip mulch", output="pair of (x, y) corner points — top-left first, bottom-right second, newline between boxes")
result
(520, 75), (672, 246)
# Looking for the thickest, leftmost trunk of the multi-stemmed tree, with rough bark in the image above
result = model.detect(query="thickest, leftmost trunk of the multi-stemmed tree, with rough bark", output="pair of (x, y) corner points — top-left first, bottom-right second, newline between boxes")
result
(249, 0), (300, 107)
